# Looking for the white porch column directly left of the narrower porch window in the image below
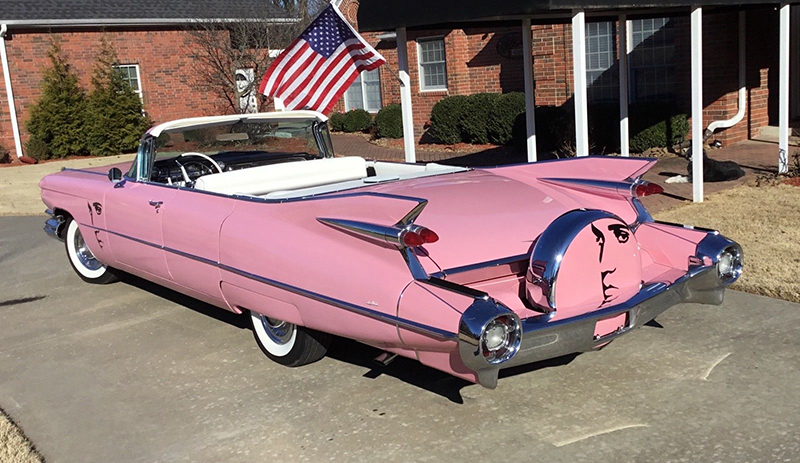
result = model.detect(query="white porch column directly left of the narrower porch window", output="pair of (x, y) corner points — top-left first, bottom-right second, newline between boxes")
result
(572, 10), (589, 156)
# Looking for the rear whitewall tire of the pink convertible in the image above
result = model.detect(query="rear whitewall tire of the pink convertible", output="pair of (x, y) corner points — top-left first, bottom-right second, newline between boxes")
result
(250, 311), (330, 367)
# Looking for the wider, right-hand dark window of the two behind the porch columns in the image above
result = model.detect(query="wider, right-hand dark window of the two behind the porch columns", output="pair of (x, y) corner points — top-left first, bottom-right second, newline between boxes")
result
(630, 18), (675, 101)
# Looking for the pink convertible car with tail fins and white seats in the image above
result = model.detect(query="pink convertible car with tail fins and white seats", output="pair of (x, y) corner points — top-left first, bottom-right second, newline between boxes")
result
(40, 111), (742, 388)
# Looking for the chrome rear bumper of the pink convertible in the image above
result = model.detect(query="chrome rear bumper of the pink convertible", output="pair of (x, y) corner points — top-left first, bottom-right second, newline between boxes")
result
(462, 266), (726, 388)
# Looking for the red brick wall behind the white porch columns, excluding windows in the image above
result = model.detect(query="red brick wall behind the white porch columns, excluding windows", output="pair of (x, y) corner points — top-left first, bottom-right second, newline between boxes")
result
(339, 0), (777, 149)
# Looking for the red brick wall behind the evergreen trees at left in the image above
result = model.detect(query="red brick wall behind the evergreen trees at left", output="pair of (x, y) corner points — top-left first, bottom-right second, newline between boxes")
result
(0, 29), (225, 149)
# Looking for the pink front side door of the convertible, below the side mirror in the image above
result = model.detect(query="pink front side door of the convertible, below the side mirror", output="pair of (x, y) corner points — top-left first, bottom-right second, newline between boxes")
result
(105, 181), (178, 280)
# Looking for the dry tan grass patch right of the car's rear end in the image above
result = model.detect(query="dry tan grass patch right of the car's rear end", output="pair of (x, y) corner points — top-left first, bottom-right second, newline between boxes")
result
(655, 184), (800, 302)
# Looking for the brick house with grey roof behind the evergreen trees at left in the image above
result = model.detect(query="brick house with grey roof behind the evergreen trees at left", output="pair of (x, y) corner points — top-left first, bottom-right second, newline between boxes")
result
(0, 0), (295, 158)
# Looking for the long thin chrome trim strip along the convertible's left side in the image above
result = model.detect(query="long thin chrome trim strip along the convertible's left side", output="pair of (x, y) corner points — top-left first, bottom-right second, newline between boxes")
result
(81, 223), (458, 341)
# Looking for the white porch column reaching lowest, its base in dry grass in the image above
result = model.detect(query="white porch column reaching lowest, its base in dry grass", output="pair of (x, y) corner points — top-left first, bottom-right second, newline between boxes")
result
(692, 6), (703, 203)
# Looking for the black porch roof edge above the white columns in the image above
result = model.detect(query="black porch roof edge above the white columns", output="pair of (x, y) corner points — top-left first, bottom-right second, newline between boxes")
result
(358, 0), (798, 32)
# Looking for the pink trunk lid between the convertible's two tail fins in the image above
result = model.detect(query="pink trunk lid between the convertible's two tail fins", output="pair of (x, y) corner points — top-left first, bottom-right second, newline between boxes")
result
(372, 169), (635, 269)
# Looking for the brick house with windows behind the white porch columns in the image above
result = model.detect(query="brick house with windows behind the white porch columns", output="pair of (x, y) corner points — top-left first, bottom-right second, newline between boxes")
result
(337, 0), (800, 152)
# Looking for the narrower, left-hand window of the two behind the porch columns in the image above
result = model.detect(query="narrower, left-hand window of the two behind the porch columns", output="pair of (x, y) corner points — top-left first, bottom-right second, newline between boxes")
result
(586, 22), (619, 102)
